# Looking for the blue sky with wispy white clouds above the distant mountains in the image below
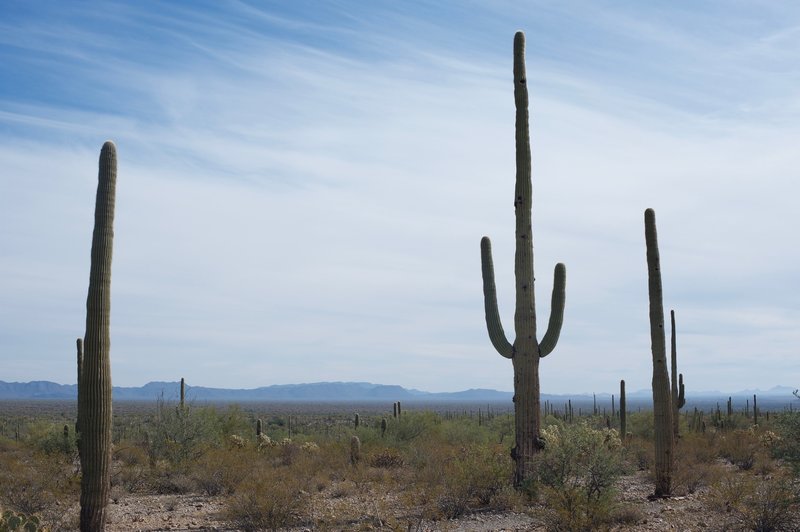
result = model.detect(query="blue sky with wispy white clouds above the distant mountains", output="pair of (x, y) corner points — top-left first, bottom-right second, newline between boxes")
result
(0, 0), (800, 393)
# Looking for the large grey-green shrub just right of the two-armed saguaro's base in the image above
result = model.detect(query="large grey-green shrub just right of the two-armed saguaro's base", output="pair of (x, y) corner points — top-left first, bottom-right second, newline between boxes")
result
(535, 423), (624, 530)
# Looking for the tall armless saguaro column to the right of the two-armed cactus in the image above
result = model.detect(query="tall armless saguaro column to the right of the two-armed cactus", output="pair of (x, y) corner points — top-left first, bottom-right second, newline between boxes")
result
(644, 209), (674, 497)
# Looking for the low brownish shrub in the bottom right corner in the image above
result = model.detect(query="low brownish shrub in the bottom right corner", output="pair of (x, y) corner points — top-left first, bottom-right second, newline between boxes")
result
(711, 473), (800, 532)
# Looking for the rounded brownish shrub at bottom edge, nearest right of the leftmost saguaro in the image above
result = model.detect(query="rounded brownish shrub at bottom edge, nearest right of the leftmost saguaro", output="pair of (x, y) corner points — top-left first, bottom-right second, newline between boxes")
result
(223, 469), (308, 531)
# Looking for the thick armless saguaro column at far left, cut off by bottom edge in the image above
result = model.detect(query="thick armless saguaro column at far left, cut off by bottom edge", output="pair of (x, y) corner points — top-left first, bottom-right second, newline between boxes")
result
(78, 141), (117, 532)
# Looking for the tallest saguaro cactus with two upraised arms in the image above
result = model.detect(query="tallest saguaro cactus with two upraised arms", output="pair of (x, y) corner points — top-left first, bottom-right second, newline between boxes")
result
(481, 32), (566, 487)
